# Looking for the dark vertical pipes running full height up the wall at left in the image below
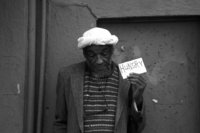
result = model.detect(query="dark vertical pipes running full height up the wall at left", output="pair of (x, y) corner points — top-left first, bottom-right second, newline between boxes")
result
(23, 0), (48, 133)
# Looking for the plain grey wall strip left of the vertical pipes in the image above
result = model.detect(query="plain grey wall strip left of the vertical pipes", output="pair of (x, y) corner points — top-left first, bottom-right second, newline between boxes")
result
(0, 0), (28, 133)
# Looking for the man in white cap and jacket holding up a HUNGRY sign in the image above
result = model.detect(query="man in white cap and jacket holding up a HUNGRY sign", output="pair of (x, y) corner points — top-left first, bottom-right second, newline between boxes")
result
(53, 27), (146, 133)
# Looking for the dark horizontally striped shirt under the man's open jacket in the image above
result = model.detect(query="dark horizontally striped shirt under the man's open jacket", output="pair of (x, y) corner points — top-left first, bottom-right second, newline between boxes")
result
(84, 67), (119, 133)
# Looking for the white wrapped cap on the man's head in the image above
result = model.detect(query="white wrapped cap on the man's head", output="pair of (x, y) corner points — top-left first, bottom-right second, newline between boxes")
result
(78, 27), (118, 49)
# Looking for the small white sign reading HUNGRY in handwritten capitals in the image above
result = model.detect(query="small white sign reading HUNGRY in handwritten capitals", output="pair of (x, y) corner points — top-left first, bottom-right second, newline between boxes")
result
(119, 58), (147, 79)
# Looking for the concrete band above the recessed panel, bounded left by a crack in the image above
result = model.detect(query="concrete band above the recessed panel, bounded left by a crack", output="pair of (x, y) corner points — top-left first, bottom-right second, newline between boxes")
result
(50, 0), (200, 18)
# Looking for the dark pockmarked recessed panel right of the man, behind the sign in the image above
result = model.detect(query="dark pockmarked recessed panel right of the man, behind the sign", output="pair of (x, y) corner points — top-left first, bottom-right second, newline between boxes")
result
(98, 19), (200, 133)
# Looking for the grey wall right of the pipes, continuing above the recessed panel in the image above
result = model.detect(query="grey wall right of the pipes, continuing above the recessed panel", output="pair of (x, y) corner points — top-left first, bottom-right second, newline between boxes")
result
(44, 0), (200, 132)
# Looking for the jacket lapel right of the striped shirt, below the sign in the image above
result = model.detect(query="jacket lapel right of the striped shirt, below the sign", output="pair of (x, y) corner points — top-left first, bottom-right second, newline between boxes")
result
(115, 68), (130, 128)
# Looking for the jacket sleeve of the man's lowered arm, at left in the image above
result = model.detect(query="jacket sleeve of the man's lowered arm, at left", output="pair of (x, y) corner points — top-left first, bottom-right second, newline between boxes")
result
(53, 71), (67, 133)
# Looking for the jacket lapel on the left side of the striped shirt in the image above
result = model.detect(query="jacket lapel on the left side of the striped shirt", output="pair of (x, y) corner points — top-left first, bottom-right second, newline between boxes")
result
(71, 62), (85, 132)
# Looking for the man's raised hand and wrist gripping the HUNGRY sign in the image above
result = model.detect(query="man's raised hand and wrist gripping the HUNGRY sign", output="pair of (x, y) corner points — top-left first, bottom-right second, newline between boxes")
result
(127, 73), (147, 105)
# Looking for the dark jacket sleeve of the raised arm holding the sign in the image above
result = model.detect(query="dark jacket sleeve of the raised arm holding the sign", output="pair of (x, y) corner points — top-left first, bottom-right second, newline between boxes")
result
(129, 85), (146, 133)
